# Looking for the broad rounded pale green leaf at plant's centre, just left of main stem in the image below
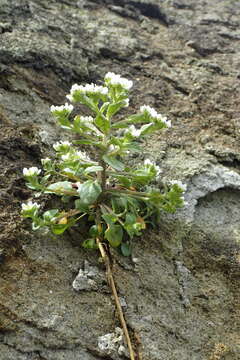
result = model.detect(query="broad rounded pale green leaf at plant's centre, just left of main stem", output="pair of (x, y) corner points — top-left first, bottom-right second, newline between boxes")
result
(78, 180), (102, 205)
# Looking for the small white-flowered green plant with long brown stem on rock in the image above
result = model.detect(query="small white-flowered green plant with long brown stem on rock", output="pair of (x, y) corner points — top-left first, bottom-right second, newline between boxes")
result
(22, 72), (185, 359)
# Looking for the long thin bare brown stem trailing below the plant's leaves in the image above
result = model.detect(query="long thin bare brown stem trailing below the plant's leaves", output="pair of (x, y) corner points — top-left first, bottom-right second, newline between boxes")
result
(97, 238), (135, 360)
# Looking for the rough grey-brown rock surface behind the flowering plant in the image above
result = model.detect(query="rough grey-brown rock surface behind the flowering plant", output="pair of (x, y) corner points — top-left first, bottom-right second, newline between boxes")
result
(0, 0), (240, 360)
